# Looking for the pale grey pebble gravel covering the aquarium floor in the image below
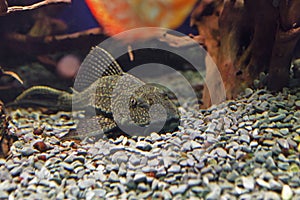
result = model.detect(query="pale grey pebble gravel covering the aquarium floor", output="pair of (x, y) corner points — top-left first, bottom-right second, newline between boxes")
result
(0, 86), (300, 200)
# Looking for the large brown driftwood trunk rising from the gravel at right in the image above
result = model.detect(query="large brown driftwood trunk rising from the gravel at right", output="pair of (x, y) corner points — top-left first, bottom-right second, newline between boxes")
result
(192, 0), (300, 107)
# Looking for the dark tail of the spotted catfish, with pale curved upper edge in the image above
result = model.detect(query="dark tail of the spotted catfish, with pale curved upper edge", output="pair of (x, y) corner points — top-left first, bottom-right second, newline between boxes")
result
(8, 86), (72, 110)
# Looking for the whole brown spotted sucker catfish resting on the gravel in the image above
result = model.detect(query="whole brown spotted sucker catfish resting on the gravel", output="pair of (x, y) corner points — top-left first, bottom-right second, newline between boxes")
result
(15, 47), (179, 136)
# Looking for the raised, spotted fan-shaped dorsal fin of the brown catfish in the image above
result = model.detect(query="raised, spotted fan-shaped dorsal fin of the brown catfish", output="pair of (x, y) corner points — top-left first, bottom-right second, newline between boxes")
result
(74, 46), (123, 91)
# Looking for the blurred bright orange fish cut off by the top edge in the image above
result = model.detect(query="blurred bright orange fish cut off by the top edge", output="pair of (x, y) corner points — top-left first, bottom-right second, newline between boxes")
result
(85, 0), (197, 35)
